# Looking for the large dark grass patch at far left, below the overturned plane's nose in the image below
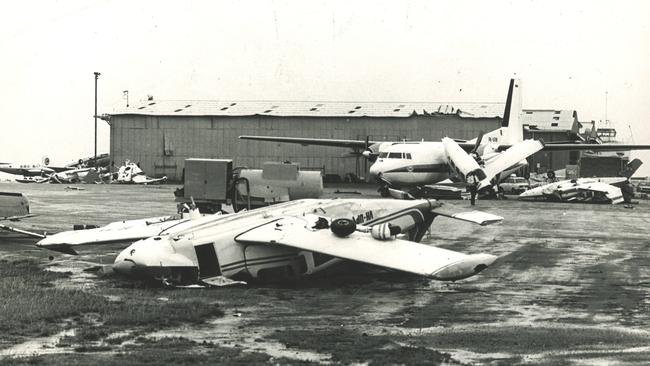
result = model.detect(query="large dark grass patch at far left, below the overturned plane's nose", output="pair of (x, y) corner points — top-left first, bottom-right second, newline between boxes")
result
(0, 260), (223, 344)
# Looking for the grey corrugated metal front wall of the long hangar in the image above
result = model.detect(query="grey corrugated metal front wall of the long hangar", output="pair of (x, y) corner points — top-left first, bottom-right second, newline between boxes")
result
(111, 115), (500, 180)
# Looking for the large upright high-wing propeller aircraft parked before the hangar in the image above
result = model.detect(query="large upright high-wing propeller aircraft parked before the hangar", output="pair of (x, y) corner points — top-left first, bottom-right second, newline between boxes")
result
(239, 79), (650, 203)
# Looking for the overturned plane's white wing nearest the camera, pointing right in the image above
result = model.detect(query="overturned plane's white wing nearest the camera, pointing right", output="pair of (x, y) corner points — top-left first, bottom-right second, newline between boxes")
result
(235, 217), (497, 281)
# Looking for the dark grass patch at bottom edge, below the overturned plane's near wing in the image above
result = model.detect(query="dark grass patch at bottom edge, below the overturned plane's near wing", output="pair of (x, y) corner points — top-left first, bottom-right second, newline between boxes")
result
(273, 329), (455, 365)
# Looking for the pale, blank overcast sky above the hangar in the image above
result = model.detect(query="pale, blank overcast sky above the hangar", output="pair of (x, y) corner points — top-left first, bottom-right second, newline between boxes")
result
(0, 0), (650, 175)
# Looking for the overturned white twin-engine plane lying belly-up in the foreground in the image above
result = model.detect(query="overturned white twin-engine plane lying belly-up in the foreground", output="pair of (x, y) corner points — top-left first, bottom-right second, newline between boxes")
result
(38, 199), (503, 286)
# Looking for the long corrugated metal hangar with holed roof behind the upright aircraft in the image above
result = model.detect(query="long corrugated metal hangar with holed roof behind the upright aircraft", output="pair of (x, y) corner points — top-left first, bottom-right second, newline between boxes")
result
(106, 100), (578, 180)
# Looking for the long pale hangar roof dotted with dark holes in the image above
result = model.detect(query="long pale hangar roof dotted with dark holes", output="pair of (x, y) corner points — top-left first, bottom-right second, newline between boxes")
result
(110, 100), (504, 118)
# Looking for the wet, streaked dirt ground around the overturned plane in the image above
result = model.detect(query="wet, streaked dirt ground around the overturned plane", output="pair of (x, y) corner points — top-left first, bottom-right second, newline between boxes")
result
(0, 183), (650, 365)
